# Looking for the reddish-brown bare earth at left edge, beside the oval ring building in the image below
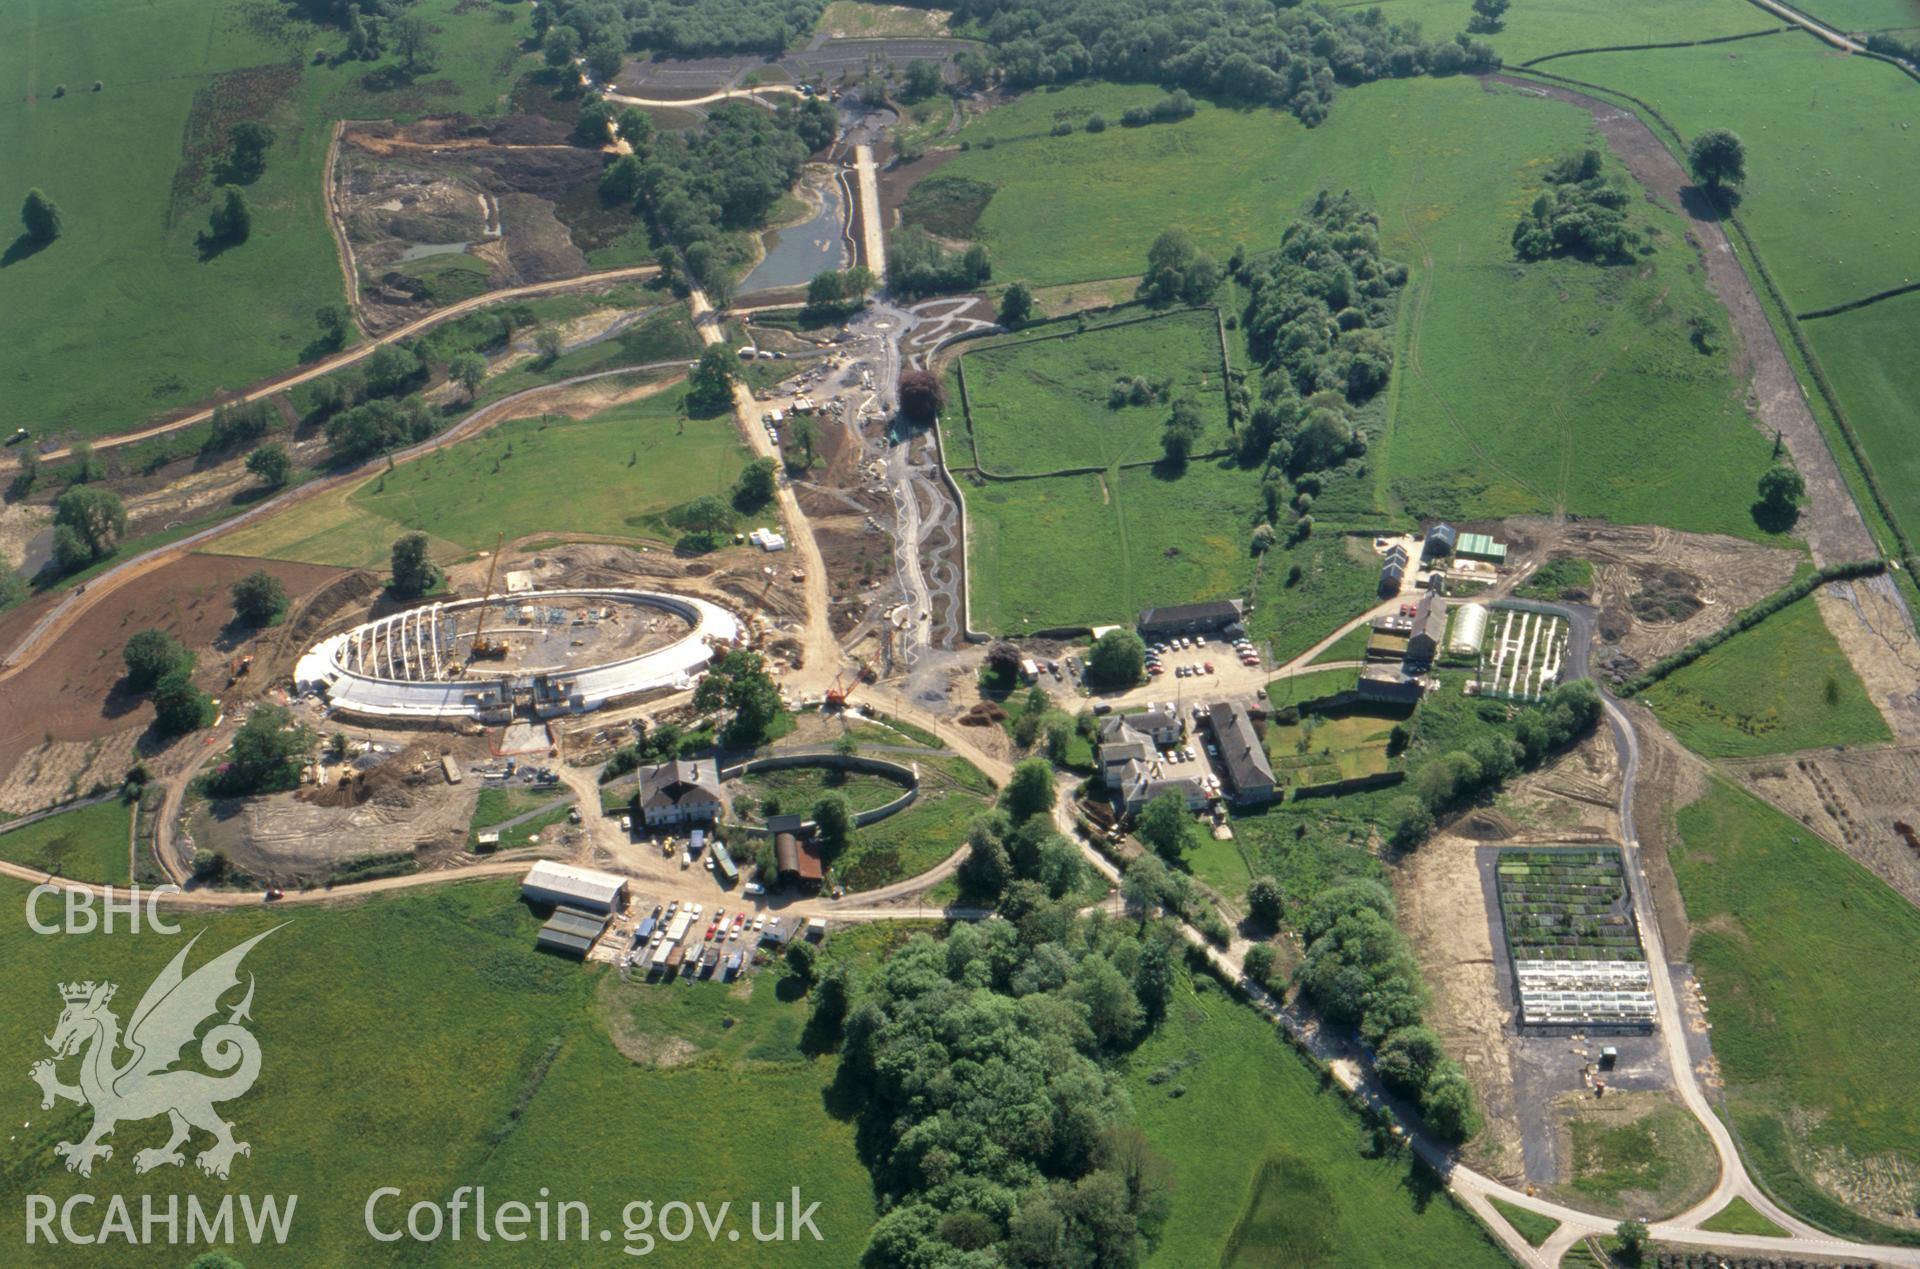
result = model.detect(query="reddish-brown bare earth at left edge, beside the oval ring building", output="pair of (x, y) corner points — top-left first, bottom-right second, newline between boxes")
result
(0, 555), (351, 814)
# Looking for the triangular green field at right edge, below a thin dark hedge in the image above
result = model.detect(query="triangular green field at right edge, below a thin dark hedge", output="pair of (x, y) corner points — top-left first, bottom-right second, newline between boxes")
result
(1803, 294), (1920, 549)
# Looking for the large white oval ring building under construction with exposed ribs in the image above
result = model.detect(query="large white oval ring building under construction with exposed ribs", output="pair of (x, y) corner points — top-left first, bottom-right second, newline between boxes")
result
(294, 587), (741, 722)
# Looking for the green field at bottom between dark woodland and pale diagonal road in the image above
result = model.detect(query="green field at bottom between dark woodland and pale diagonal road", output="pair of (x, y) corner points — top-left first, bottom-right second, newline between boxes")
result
(1125, 963), (1507, 1269)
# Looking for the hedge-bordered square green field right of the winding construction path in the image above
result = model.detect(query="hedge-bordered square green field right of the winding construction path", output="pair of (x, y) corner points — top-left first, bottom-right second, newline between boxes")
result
(947, 311), (1229, 476)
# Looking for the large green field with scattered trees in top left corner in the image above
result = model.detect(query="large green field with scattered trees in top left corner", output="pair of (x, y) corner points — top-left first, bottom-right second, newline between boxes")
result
(0, 0), (526, 436)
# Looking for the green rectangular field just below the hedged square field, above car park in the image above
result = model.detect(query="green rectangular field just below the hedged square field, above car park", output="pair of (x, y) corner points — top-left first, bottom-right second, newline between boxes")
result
(964, 463), (1260, 635)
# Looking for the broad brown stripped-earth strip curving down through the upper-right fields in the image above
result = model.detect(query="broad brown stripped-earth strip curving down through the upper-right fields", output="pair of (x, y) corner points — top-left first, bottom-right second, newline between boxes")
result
(1480, 75), (1880, 564)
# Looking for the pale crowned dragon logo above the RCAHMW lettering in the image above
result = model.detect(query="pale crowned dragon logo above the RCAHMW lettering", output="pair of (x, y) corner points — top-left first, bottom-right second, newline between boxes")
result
(27, 927), (278, 1181)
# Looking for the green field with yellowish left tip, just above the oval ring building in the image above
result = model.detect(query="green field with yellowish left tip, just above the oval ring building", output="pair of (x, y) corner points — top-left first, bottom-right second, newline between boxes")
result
(221, 388), (749, 568)
